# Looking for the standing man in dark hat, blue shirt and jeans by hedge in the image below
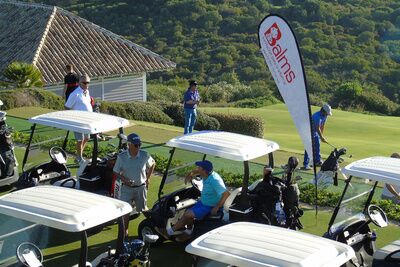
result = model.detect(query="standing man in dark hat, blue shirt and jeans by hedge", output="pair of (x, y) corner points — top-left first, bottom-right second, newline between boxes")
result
(183, 81), (200, 134)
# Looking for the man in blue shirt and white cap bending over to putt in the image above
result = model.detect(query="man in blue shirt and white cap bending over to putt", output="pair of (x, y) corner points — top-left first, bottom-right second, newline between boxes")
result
(303, 104), (332, 170)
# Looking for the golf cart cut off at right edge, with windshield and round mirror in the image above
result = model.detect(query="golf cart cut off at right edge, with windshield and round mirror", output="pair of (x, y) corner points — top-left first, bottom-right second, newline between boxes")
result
(324, 157), (400, 267)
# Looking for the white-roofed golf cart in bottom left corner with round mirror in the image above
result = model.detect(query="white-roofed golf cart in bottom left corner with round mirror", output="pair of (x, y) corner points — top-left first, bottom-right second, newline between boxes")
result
(0, 185), (158, 267)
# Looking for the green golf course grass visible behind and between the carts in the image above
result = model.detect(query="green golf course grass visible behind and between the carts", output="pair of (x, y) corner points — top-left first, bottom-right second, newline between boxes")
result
(1, 105), (400, 267)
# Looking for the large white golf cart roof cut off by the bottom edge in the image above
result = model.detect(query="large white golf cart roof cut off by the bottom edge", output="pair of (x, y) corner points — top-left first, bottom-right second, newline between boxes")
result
(186, 222), (354, 267)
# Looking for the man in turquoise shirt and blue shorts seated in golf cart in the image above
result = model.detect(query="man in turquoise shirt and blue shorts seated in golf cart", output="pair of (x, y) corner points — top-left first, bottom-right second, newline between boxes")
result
(167, 160), (230, 236)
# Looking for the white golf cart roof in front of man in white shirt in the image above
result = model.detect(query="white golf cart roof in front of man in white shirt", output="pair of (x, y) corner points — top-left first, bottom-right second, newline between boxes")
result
(29, 110), (129, 134)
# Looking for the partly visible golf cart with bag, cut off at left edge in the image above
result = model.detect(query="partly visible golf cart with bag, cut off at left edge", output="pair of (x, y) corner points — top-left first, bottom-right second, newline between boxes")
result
(0, 100), (19, 187)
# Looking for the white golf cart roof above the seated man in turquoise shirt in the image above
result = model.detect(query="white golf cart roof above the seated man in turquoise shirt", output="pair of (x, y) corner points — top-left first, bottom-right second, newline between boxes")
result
(167, 131), (279, 161)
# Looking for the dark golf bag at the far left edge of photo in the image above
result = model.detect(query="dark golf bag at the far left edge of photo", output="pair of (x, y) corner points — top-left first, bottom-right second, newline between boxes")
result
(0, 120), (16, 179)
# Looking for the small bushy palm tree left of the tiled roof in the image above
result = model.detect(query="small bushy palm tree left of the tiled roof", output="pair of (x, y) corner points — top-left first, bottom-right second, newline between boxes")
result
(3, 61), (43, 88)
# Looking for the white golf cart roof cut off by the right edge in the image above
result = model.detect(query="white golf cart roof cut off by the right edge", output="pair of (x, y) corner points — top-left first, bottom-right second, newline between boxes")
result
(342, 157), (400, 185)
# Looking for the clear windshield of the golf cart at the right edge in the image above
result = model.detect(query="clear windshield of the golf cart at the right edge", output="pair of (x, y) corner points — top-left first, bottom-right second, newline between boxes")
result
(330, 177), (375, 232)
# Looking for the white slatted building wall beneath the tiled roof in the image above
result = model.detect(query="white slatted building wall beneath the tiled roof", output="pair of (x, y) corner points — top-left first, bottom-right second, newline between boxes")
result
(44, 73), (147, 102)
